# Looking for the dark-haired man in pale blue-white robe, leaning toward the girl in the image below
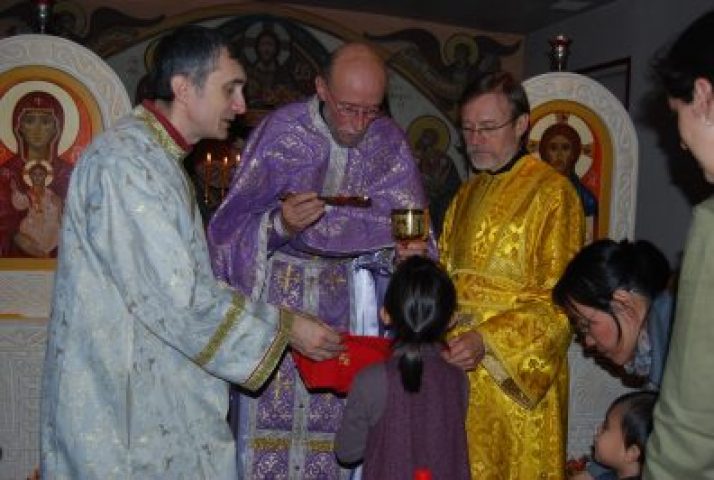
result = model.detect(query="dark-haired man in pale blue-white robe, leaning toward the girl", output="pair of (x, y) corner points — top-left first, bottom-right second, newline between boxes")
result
(41, 27), (341, 480)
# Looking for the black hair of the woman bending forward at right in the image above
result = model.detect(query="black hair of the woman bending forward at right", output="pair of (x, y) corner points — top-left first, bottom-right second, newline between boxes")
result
(553, 239), (670, 338)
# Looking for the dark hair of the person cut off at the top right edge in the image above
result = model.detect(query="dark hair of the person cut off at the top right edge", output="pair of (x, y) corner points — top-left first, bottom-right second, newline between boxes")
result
(653, 10), (714, 103)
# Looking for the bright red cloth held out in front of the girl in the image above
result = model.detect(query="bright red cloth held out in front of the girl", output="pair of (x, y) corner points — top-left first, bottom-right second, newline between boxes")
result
(291, 334), (392, 393)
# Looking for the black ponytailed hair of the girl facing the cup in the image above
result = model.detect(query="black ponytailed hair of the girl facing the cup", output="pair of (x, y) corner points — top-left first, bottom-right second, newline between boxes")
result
(384, 256), (456, 392)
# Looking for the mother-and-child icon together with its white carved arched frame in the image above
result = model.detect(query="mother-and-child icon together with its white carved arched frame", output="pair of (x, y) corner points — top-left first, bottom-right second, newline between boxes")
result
(0, 35), (130, 271)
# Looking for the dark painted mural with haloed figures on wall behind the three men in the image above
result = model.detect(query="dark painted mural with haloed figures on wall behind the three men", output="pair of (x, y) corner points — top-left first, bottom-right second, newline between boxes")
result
(0, 0), (521, 234)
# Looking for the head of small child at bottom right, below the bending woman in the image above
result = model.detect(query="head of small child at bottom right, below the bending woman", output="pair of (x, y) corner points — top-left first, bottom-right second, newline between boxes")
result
(580, 391), (657, 480)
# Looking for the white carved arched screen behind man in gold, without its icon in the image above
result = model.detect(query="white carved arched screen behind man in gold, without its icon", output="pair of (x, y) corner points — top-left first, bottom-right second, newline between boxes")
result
(524, 72), (638, 458)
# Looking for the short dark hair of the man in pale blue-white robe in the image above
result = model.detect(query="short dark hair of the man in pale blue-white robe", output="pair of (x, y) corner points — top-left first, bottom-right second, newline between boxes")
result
(146, 25), (237, 101)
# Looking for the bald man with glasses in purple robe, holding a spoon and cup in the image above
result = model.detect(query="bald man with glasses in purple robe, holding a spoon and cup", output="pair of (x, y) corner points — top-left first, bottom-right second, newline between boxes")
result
(208, 44), (426, 479)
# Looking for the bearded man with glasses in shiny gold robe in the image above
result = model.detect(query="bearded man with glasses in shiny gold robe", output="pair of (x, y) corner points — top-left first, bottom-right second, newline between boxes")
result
(440, 72), (584, 480)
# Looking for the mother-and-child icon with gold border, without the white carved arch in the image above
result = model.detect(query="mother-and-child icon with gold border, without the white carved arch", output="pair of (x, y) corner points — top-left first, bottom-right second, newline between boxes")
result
(0, 67), (101, 258)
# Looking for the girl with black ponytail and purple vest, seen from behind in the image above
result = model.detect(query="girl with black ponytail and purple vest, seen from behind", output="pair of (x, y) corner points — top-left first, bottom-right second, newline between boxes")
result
(335, 256), (470, 480)
